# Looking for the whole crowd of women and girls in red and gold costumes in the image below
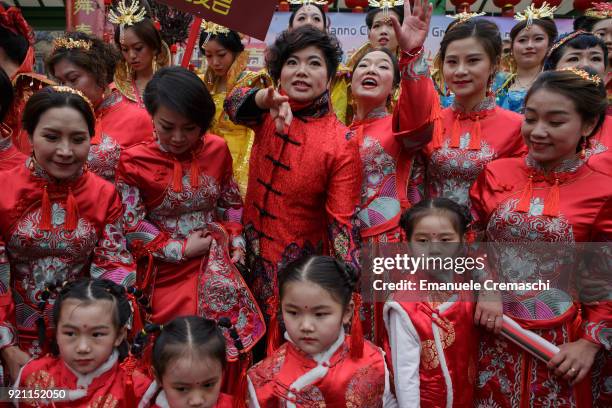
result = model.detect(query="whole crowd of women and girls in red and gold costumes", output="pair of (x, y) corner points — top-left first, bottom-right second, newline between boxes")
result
(0, 0), (612, 408)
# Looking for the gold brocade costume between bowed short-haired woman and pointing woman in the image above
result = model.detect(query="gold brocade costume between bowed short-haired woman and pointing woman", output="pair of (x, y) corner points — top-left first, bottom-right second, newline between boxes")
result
(200, 51), (272, 199)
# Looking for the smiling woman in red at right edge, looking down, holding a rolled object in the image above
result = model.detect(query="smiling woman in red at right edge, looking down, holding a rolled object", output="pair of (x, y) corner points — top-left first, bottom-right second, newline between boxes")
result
(470, 68), (612, 408)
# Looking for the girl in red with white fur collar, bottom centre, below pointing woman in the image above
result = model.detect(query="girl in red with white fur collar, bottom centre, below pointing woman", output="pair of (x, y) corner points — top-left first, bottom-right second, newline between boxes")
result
(248, 256), (395, 407)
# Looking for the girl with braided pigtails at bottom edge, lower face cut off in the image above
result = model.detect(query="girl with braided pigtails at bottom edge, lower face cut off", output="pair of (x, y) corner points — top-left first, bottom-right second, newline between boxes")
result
(132, 316), (246, 408)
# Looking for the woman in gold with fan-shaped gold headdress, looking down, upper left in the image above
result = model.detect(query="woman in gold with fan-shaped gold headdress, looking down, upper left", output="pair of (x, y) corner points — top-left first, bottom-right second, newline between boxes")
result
(108, 0), (172, 110)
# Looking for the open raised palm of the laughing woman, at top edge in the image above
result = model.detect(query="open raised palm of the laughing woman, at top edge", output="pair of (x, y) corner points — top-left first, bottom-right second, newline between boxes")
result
(390, 0), (433, 52)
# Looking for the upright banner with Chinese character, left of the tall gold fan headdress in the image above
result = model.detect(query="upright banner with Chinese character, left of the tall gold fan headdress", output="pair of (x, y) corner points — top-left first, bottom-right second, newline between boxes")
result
(66, 0), (105, 38)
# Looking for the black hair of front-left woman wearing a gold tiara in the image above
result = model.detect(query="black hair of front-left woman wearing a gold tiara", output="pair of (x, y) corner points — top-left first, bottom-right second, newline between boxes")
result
(21, 86), (96, 137)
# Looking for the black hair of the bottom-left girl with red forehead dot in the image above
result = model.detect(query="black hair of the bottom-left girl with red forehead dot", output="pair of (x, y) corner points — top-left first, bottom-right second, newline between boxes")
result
(52, 278), (132, 360)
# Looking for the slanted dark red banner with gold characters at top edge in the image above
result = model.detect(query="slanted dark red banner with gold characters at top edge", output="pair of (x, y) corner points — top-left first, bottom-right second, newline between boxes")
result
(155, 0), (278, 40)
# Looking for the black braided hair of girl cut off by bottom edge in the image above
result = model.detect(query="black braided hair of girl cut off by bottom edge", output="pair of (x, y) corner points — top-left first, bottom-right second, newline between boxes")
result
(132, 316), (227, 380)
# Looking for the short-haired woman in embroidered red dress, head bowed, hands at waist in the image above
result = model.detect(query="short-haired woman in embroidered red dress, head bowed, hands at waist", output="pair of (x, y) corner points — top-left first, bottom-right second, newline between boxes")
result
(117, 67), (265, 396)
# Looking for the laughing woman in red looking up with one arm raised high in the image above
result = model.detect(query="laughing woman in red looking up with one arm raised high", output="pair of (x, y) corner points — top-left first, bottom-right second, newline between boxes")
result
(350, 2), (439, 344)
